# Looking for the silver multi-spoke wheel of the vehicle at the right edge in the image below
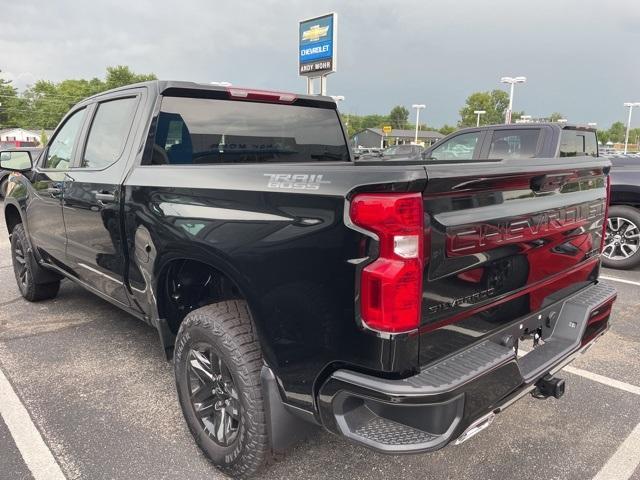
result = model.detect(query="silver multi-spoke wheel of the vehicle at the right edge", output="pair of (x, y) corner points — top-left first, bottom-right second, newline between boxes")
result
(602, 205), (640, 269)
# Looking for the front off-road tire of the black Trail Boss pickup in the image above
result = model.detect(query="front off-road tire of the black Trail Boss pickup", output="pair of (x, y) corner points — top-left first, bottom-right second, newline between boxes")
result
(11, 223), (60, 302)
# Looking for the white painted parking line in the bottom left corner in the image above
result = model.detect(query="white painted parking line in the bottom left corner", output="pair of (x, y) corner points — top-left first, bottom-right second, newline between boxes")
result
(0, 370), (65, 480)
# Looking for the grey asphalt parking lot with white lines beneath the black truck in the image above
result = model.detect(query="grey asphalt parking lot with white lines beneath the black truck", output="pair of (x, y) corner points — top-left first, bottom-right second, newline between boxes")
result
(0, 207), (640, 480)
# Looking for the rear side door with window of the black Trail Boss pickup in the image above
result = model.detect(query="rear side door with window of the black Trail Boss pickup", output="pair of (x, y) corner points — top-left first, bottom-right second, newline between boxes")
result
(63, 91), (141, 305)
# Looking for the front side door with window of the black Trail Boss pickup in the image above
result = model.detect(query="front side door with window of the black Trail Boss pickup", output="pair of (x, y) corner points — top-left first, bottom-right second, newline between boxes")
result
(26, 108), (87, 268)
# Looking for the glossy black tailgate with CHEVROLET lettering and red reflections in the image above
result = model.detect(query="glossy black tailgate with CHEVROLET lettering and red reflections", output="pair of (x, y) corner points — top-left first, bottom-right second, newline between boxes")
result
(420, 157), (609, 366)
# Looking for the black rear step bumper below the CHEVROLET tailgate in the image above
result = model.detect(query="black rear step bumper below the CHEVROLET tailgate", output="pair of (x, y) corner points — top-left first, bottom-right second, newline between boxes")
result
(318, 283), (616, 453)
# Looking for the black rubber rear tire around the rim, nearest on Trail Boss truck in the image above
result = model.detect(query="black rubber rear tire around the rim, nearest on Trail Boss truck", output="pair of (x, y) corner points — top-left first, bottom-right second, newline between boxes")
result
(173, 300), (271, 478)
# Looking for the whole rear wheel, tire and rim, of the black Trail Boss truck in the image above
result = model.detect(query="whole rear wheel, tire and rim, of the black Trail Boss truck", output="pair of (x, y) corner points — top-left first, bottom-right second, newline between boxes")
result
(174, 301), (271, 478)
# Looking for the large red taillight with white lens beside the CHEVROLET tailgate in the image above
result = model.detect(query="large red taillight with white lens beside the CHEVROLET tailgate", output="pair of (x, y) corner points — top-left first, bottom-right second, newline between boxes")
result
(350, 193), (424, 333)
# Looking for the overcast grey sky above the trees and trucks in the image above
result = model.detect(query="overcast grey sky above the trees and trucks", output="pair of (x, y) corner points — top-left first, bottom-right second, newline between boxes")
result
(0, 0), (640, 127)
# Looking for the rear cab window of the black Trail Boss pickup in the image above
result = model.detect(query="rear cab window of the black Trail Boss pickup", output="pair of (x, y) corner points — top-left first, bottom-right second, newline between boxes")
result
(146, 97), (349, 165)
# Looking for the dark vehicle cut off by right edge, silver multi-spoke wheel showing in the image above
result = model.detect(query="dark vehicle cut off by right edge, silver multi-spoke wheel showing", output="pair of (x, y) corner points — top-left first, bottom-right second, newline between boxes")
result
(602, 155), (640, 269)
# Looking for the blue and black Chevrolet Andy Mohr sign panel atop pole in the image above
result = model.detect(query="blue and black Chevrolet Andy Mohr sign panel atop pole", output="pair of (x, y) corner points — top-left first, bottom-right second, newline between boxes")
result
(298, 13), (338, 78)
